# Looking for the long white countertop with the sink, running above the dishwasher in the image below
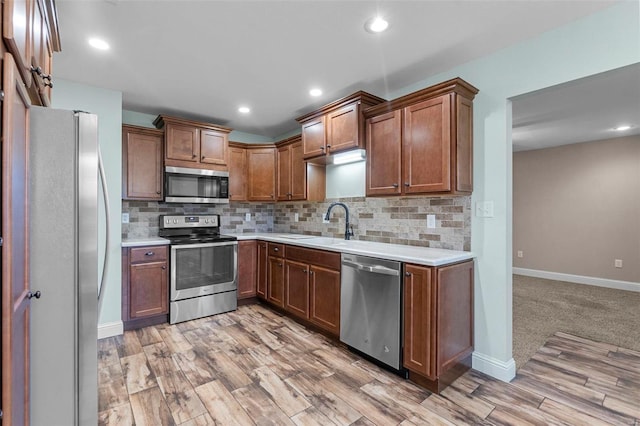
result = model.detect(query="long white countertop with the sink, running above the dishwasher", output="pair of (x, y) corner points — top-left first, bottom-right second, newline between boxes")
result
(228, 232), (475, 266)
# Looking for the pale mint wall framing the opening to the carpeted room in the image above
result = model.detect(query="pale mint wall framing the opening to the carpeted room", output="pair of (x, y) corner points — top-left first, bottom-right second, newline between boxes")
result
(382, 1), (640, 380)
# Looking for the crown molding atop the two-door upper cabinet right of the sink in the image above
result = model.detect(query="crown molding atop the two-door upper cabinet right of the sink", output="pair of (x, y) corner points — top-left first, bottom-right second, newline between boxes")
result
(362, 77), (479, 118)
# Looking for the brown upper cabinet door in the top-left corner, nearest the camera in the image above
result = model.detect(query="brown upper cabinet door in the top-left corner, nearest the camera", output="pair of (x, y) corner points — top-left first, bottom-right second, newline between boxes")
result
(2, 0), (35, 88)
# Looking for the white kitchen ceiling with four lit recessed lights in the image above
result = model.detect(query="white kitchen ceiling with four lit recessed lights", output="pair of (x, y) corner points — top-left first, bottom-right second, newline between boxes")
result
(54, 0), (612, 137)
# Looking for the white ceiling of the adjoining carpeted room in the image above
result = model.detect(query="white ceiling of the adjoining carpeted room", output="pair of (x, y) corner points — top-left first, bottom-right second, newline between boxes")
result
(512, 64), (640, 151)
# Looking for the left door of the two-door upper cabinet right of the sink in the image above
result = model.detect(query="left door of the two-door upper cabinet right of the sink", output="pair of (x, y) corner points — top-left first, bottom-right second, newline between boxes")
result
(366, 110), (402, 195)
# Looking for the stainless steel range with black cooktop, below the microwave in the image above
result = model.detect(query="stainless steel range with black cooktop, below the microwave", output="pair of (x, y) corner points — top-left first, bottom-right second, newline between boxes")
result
(158, 215), (238, 324)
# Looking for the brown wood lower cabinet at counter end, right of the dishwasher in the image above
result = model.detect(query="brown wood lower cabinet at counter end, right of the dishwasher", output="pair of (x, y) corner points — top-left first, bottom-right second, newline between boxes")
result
(403, 260), (473, 392)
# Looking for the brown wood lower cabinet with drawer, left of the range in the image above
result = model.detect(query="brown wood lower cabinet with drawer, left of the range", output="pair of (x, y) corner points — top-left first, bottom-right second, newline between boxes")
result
(122, 246), (169, 330)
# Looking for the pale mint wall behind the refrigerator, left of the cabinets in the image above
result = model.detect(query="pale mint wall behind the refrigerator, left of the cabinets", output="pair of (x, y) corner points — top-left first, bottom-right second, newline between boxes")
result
(52, 79), (122, 327)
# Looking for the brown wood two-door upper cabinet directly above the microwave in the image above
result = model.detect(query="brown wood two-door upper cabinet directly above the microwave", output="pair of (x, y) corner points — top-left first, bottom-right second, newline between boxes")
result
(153, 115), (231, 171)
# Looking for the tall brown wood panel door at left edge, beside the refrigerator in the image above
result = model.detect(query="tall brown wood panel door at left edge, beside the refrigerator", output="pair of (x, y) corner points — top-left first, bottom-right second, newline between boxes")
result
(0, 52), (31, 425)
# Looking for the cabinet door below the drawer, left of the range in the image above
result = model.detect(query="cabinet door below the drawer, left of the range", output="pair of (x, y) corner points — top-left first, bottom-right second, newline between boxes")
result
(129, 262), (169, 319)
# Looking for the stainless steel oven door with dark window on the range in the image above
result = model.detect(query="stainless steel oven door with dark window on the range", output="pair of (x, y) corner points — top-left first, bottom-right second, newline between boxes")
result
(171, 241), (238, 301)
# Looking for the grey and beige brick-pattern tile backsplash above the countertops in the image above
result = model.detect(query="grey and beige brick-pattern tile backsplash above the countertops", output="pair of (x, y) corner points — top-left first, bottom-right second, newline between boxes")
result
(122, 196), (471, 251)
